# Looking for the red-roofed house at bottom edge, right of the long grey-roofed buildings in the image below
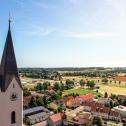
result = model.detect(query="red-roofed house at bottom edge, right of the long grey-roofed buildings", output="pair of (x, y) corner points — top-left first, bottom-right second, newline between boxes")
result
(48, 113), (64, 126)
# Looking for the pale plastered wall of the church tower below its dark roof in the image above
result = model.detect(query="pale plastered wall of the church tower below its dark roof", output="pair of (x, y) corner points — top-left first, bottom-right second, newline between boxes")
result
(0, 78), (23, 126)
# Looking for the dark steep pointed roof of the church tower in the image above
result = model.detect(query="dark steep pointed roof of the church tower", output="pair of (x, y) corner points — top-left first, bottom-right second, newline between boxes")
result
(0, 20), (21, 91)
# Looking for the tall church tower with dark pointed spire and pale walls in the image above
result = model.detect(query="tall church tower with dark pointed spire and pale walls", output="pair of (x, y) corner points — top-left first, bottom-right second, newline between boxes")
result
(0, 20), (23, 126)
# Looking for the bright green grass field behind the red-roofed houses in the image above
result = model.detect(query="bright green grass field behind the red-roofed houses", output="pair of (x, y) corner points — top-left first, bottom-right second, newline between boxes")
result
(63, 89), (101, 95)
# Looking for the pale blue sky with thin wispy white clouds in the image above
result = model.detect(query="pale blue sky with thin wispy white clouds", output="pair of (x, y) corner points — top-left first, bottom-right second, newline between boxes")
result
(0, 0), (126, 67)
